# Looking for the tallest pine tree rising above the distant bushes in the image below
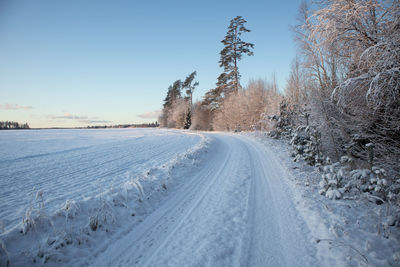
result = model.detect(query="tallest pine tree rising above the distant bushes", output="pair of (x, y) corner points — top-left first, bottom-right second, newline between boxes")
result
(217, 16), (254, 94)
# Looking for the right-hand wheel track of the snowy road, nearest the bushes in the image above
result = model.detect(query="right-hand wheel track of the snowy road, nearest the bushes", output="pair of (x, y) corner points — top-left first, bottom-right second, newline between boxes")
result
(240, 137), (317, 266)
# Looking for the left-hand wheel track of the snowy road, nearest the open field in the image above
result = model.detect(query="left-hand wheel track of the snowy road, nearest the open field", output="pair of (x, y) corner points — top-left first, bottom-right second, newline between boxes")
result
(84, 136), (231, 266)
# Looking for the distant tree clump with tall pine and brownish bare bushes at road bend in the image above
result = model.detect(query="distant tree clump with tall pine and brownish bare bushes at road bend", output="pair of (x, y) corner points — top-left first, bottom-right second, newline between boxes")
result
(159, 16), (281, 131)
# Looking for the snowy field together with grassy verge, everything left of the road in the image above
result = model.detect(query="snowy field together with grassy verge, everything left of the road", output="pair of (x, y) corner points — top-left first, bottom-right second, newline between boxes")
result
(0, 129), (208, 266)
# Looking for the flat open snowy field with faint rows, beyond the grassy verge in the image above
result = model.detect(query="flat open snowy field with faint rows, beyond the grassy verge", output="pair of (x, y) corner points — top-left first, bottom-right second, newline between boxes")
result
(0, 129), (201, 230)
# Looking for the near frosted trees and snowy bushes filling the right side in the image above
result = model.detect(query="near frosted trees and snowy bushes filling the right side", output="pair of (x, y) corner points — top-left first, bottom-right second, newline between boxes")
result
(271, 0), (400, 206)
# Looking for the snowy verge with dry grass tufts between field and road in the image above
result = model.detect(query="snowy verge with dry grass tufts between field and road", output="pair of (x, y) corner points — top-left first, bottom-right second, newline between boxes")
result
(0, 131), (211, 266)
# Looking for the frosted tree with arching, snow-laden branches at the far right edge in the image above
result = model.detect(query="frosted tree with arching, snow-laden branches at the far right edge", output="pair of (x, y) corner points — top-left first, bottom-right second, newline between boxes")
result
(309, 0), (400, 170)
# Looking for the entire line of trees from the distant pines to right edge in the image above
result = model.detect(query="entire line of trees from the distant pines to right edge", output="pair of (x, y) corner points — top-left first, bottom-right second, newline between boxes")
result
(160, 0), (400, 177)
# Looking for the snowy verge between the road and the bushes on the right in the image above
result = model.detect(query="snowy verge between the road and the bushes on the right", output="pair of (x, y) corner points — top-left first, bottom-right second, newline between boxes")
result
(244, 132), (400, 266)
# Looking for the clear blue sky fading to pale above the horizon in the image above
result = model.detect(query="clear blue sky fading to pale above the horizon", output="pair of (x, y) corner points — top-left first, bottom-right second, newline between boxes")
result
(0, 0), (301, 127)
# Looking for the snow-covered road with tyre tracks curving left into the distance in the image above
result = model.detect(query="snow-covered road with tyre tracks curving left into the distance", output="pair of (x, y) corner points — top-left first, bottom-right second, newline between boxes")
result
(86, 133), (319, 266)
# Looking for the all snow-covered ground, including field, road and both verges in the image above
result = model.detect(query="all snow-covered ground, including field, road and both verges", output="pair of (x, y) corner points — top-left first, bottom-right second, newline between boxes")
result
(0, 129), (400, 266)
